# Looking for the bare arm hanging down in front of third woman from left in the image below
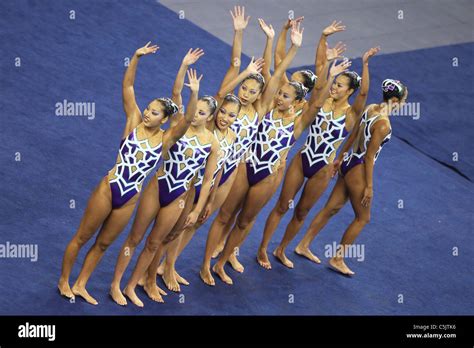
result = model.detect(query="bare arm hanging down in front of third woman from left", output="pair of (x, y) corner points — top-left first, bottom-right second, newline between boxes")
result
(184, 136), (220, 228)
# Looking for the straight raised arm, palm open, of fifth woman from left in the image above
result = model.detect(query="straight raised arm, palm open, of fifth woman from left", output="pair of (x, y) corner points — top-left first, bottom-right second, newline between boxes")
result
(256, 23), (304, 119)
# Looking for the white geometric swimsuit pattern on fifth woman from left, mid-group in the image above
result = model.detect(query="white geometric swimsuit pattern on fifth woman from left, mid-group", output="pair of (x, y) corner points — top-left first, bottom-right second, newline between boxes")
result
(249, 110), (295, 175)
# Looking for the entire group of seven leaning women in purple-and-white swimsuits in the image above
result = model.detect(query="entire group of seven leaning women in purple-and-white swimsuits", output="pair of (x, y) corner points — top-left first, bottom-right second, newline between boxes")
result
(58, 6), (408, 307)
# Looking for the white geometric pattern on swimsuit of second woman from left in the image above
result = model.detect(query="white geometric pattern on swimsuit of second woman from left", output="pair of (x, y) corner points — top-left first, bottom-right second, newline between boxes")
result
(159, 135), (212, 193)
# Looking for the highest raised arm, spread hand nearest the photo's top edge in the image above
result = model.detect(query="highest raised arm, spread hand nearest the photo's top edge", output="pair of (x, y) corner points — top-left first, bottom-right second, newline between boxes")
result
(216, 6), (250, 104)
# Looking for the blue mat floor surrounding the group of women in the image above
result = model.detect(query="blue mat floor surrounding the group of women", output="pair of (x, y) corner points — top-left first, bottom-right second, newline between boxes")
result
(0, 0), (474, 315)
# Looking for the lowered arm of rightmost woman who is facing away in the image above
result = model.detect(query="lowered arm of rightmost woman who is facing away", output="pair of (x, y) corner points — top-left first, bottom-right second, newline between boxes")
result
(361, 120), (390, 207)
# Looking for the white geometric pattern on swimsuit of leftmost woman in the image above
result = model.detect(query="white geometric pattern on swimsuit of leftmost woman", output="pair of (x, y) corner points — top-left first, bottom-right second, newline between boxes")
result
(109, 128), (162, 197)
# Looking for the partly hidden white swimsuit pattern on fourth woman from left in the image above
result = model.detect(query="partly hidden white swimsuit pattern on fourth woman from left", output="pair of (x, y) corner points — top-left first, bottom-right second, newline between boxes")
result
(225, 113), (258, 168)
